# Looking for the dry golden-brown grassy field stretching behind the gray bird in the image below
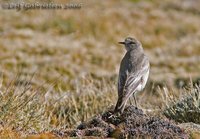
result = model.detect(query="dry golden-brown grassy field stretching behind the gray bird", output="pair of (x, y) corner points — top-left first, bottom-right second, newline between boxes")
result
(0, 0), (200, 138)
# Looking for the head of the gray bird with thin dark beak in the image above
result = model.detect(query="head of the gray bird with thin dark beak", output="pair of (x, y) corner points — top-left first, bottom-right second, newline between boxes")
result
(119, 37), (141, 51)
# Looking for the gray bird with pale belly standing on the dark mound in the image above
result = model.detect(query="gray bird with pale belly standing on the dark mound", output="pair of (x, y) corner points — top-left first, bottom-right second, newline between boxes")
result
(114, 37), (150, 113)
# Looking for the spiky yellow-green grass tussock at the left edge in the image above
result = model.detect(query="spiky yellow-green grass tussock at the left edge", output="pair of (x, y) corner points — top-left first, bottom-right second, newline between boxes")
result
(0, 75), (48, 132)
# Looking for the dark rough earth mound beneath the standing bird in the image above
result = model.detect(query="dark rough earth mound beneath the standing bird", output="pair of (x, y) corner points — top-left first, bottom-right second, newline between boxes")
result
(52, 106), (189, 139)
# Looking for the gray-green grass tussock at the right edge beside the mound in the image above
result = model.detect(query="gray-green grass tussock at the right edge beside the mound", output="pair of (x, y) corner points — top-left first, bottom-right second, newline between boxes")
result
(163, 86), (200, 124)
